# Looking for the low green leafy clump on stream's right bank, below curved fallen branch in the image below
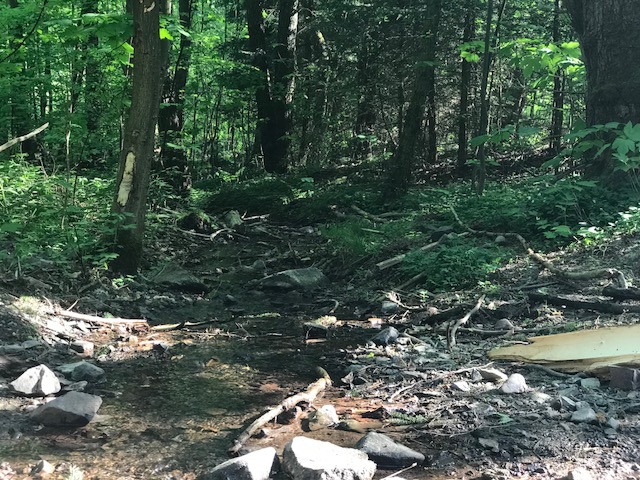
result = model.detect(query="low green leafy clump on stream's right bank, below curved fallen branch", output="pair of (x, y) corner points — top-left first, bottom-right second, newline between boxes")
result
(400, 238), (511, 292)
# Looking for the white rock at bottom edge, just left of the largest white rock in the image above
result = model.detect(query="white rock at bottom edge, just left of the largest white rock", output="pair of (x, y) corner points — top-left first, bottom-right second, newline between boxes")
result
(200, 447), (278, 480)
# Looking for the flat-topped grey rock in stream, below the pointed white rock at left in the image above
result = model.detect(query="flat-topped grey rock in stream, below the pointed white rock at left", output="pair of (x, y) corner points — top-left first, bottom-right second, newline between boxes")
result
(30, 392), (102, 427)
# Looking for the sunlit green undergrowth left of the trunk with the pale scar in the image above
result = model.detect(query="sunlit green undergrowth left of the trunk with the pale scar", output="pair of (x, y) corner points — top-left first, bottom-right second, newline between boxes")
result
(0, 161), (122, 270)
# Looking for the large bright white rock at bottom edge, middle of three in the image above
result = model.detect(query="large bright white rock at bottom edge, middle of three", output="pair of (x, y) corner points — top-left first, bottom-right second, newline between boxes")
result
(282, 437), (376, 480)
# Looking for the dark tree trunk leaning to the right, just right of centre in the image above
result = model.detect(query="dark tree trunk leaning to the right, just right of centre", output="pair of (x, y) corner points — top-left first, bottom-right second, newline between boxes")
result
(385, 0), (441, 198)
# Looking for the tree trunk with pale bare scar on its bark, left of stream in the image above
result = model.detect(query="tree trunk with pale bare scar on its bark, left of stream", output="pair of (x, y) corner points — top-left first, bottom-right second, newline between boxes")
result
(112, 0), (162, 274)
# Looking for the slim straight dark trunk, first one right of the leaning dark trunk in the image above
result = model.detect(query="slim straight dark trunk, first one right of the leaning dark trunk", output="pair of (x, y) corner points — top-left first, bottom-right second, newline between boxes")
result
(456, 0), (476, 176)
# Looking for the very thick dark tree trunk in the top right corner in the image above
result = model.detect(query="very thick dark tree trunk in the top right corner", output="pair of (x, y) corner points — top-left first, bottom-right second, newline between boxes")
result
(564, 0), (640, 177)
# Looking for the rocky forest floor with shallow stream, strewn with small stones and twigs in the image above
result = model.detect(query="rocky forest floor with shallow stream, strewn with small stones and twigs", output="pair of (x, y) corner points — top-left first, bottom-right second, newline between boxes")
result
(0, 201), (640, 480)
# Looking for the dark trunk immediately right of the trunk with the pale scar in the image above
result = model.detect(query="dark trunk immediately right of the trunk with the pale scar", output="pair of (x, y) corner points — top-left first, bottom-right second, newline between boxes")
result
(158, 0), (193, 194)
